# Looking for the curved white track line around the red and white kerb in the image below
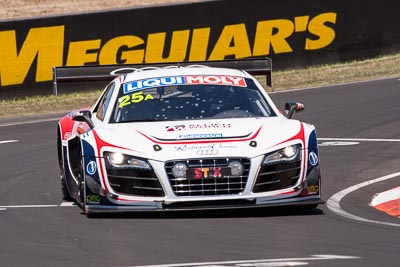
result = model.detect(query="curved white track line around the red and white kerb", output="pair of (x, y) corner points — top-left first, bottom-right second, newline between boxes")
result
(326, 172), (400, 227)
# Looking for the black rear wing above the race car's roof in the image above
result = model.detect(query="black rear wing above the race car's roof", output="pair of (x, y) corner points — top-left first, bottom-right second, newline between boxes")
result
(53, 58), (272, 95)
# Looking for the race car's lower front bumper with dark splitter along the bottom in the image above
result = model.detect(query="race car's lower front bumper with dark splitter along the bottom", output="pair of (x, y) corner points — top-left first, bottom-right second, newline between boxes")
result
(84, 151), (324, 214)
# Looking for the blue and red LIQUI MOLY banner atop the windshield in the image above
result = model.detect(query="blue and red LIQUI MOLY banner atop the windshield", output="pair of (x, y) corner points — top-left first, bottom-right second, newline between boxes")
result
(122, 76), (246, 94)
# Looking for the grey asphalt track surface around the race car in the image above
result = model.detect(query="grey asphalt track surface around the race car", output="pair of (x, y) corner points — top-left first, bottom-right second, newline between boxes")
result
(0, 78), (400, 267)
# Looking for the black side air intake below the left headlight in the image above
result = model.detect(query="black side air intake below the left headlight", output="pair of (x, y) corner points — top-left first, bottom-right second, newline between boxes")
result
(107, 167), (164, 197)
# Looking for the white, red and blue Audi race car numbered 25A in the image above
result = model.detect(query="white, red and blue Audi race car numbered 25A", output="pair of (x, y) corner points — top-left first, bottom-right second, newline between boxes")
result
(53, 58), (323, 214)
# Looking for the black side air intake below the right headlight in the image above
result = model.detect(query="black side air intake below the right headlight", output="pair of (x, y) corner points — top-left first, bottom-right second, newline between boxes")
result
(253, 159), (301, 193)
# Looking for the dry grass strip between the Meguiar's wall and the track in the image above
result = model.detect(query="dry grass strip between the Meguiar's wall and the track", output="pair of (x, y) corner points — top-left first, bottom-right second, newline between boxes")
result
(0, 54), (400, 118)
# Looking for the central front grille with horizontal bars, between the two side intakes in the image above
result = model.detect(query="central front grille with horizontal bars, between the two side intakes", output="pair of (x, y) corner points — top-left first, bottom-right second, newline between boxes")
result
(165, 158), (250, 196)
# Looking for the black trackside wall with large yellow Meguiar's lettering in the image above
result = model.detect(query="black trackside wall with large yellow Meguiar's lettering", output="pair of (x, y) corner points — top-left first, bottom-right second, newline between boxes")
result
(0, 0), (400, 92)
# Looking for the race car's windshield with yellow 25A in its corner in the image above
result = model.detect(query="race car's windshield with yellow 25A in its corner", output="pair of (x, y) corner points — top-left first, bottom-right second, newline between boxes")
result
(110, 76), (275, 123)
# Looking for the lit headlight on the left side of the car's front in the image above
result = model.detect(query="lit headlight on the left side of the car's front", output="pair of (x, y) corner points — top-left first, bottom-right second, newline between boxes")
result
(104, 152), (151, 170)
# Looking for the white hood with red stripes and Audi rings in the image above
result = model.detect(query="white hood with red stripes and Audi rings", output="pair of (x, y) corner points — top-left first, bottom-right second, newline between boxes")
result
(95, 117), (304, 161)
